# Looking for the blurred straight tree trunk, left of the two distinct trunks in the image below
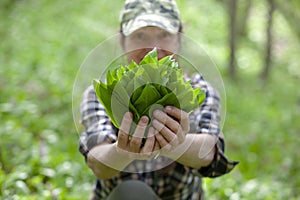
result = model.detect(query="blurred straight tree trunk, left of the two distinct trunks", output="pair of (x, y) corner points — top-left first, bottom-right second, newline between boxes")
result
(228, 0), (237, 79)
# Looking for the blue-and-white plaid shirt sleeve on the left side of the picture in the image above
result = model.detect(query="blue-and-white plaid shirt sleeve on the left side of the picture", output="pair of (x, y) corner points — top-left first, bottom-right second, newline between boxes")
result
(79, 86), (117, 157)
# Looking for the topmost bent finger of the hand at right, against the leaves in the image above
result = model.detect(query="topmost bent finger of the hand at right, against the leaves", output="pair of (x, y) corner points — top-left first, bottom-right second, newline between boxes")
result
(165, 106), (190, 133)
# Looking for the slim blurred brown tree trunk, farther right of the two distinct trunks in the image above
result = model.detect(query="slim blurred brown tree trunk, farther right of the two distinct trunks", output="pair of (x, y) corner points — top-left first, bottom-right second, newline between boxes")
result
(261, 0), (275, 80)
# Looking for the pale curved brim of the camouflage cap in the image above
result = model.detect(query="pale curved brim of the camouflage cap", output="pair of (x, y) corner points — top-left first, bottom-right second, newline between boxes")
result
(122, 14), (180, 36)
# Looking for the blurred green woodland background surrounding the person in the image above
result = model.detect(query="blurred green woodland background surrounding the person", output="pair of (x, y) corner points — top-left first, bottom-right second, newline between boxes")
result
(0, 0), (300, 200)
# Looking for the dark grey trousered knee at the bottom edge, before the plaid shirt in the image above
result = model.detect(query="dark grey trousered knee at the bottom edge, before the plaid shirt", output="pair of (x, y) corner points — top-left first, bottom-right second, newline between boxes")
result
(107, 180), (159, 200)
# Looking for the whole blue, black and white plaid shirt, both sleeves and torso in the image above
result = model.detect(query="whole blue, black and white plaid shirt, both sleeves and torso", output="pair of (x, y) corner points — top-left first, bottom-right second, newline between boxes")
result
(79, 74), (238, 200)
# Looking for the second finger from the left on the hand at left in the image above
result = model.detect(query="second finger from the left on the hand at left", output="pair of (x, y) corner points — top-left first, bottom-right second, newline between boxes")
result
(129, 116), (149, 153)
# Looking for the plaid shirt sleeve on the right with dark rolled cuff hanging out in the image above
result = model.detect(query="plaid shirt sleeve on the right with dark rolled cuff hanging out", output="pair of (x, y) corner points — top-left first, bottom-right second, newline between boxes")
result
(191, 74), (239, 177)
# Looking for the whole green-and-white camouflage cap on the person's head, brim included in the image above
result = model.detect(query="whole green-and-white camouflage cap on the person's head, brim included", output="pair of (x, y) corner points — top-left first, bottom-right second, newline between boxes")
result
(120, 0), (180, 36)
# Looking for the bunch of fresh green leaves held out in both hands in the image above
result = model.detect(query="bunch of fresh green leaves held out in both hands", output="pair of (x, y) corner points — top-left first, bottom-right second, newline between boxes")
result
(94, 49), (205, 128)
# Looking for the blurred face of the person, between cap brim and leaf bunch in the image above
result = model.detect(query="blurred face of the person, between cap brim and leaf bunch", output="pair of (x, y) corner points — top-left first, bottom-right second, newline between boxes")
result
(122, 26), (180, 63)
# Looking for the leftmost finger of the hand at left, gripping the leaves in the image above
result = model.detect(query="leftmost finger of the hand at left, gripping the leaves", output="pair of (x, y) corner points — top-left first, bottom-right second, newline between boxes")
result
(117, 112), (132, 149)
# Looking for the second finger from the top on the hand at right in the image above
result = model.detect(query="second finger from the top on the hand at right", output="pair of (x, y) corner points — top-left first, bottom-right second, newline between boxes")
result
(153, 110), (182, 134)
